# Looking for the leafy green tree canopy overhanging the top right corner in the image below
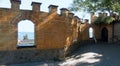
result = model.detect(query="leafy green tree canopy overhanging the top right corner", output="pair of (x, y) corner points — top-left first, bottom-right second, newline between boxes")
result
(69, 0), (120, 14)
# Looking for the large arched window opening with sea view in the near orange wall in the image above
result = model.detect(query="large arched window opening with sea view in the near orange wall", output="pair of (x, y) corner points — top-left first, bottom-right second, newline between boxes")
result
(17, 20), (35, 47)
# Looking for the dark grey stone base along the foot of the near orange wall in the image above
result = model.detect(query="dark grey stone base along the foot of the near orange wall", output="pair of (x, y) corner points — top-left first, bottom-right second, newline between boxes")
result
(0, 48), (63, 64)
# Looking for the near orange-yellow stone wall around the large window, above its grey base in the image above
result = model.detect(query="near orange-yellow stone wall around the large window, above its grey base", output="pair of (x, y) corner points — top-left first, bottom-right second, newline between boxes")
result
(0, 0), (77, 50)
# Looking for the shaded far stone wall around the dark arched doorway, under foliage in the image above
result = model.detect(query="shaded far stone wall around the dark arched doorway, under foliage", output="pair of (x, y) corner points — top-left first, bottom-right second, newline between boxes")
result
(91, 13), (113, 42)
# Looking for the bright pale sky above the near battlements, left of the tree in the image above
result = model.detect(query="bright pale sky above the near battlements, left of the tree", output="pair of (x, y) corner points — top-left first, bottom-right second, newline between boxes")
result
(0, 0), (73, 12)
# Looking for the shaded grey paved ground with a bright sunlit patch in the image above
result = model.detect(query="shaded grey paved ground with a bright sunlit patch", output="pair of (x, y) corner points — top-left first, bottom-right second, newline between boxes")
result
(1, 43), (120, 66)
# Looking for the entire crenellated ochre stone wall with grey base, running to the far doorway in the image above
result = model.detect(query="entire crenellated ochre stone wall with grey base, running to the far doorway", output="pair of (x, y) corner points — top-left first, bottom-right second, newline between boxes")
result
(0, 0), (116, 64)
